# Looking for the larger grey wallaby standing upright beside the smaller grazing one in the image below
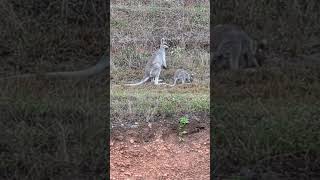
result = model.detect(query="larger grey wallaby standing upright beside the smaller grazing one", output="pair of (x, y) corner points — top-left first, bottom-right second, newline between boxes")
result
(125, 38), (169, 86)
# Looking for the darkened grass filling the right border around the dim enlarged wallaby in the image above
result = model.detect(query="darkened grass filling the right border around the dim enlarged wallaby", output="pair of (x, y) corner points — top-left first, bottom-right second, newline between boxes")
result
(210, 0), (320, 179)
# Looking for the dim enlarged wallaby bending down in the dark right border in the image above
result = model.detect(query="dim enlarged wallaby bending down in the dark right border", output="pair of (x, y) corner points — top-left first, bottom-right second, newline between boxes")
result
(213, 24), (260, 70)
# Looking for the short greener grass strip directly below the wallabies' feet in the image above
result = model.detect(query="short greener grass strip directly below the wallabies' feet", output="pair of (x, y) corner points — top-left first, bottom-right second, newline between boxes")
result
(111, 88), (210, 116)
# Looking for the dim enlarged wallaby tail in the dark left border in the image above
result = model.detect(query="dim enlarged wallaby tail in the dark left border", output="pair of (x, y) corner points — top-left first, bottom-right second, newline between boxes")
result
(0, 54), (109, 80)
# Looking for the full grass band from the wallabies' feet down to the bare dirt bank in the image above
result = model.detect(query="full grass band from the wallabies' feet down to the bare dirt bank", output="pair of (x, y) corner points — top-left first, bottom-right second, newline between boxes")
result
(111, 85), (209, 127)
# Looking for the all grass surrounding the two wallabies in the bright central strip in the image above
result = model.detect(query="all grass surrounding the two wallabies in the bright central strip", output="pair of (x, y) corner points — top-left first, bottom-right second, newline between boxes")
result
(111, 1), (209, 137)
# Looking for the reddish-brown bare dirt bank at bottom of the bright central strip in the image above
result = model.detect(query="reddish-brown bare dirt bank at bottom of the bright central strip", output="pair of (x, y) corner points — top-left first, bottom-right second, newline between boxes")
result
(110, 119), (210, 180)
